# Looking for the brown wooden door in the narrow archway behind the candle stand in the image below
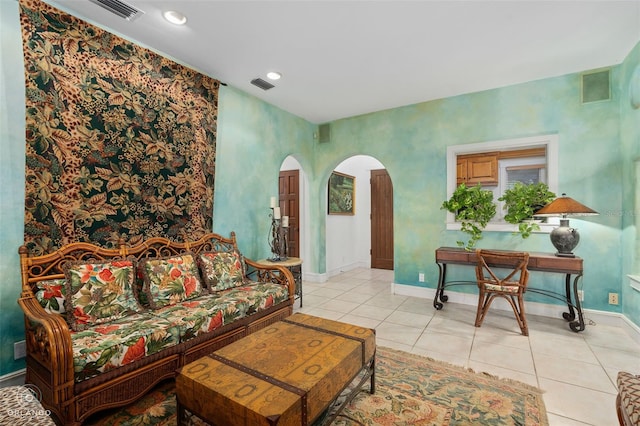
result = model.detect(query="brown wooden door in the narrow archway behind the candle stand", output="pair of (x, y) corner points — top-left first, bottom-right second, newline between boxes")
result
(278, 170), (300, 257)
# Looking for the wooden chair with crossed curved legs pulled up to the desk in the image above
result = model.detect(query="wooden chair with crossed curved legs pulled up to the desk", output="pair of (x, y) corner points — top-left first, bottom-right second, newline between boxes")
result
(475, 249), (529, 336)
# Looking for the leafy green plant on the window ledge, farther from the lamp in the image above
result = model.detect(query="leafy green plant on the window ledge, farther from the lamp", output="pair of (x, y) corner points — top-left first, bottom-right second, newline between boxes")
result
(441, 183), (496, 250)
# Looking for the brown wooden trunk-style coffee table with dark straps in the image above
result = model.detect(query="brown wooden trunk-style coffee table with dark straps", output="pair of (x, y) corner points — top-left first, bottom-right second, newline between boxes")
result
(176, 313), (376, 426)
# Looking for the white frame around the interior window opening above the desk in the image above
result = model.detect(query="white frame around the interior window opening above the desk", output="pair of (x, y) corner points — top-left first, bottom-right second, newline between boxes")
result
(446, 134), (559, 234)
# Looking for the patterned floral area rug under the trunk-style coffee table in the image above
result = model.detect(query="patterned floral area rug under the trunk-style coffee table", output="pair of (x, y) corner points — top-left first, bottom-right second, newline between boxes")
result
(85, 347), (548, 426)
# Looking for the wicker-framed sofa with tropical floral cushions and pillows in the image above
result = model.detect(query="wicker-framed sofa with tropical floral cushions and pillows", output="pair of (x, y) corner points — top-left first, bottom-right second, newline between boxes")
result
(18, 232), (295, 425)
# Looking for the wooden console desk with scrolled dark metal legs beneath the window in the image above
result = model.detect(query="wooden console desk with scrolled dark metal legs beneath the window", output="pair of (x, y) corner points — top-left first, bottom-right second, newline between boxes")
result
(433, 247), (585, 332)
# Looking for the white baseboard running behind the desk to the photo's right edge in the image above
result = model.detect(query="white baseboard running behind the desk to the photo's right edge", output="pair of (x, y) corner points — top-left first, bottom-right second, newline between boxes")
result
(391, 283), (640, 343)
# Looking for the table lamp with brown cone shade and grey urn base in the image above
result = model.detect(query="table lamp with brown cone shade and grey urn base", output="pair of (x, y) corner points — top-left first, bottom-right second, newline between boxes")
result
(533, 194), (599, 257)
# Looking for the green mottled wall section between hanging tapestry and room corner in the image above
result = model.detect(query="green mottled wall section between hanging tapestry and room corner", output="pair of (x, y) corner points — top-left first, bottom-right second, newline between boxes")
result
(213, 86), (316, 259)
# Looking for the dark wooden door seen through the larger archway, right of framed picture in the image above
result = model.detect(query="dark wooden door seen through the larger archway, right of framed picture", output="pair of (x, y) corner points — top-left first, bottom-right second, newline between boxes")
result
(371, 169), (393, 269)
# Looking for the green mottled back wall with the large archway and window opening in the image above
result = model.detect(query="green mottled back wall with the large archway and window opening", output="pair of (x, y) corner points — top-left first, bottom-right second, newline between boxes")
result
(315, 67), (623, 311)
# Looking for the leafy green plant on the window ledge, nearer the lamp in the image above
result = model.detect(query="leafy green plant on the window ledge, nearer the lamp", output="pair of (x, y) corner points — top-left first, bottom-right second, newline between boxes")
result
(498, 182), (556, 238)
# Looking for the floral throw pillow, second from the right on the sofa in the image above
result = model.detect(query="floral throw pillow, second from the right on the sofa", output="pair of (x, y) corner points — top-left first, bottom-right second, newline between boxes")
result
(140, 253), (202, 309)
